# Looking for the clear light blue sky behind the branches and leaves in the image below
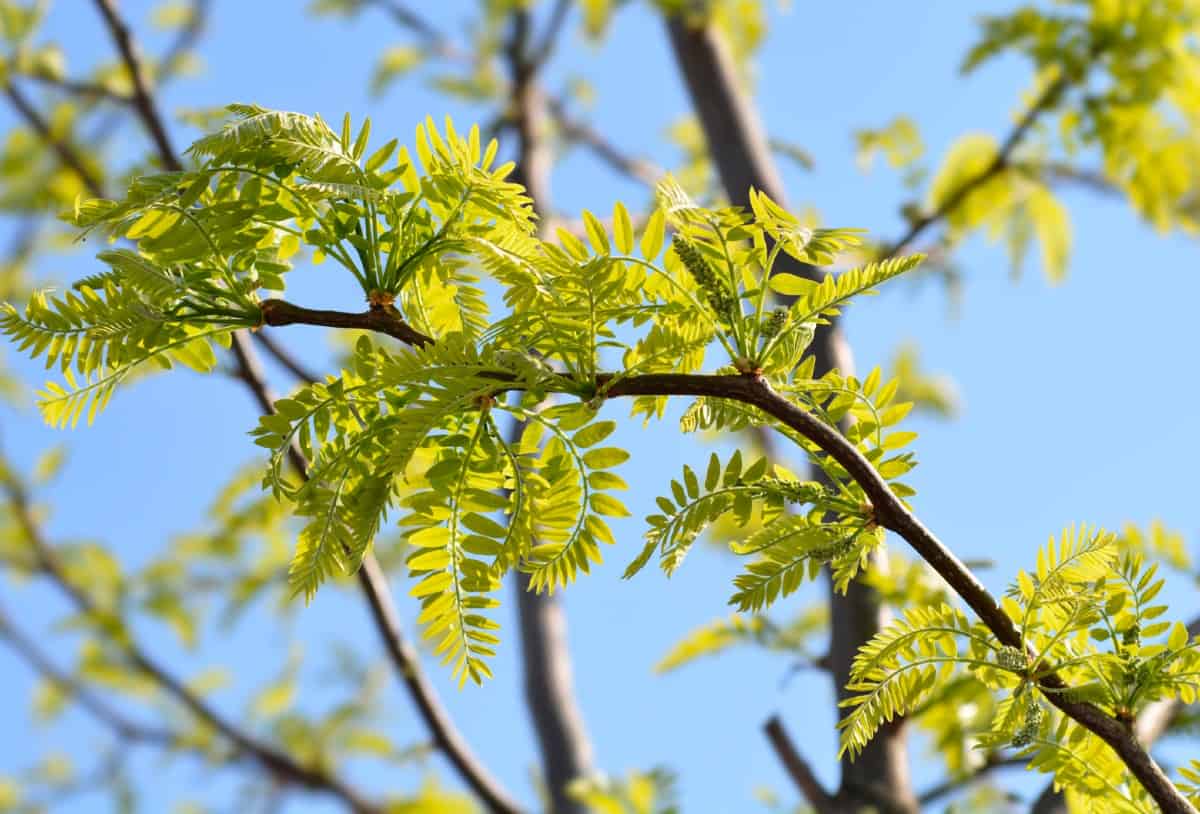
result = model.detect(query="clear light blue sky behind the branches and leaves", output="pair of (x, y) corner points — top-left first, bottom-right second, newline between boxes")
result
(0, 0), (1200, 812)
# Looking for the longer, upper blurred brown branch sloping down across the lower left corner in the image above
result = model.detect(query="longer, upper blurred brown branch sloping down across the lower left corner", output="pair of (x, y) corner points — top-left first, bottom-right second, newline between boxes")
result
(4, 478), (382, 814)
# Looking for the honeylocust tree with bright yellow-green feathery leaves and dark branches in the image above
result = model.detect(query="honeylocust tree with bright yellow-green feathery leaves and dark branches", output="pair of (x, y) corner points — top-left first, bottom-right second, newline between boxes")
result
(0, 0), (1200, 812)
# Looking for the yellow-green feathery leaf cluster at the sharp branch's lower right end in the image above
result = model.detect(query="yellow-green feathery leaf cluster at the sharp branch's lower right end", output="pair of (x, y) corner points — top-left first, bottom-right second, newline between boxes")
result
(840, 527), (1200, 812)
